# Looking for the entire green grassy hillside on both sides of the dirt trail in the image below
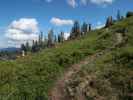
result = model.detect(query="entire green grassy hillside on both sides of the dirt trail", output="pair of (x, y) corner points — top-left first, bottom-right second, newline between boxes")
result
(0, 17), (133, 100)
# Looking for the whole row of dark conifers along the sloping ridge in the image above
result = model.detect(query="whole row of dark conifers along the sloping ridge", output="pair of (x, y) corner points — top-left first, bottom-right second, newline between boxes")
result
(21, 10), (133, 52)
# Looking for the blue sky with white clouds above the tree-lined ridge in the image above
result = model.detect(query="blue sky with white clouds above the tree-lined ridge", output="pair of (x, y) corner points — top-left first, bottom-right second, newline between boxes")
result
(0, 0), (133, 48)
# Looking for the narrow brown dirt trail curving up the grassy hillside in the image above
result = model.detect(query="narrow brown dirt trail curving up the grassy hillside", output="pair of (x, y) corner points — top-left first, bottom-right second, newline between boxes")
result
(49, 52), (104, 100)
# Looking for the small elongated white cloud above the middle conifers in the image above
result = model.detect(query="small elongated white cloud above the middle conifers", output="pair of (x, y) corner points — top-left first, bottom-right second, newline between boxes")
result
(50, 17), (73, 26)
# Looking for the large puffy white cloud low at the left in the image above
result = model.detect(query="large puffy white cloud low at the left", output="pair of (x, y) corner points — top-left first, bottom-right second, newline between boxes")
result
(5, 18), (39, 45)
